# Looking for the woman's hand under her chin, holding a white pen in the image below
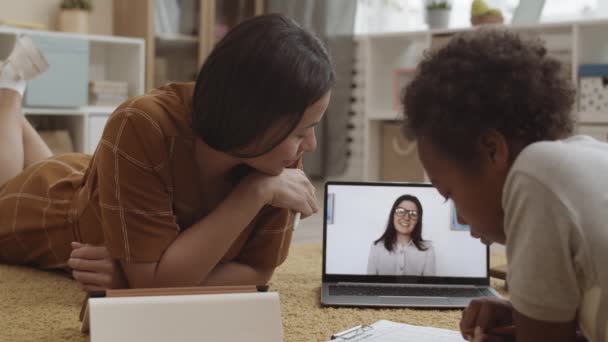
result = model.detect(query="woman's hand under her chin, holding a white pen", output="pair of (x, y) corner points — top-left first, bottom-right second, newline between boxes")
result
(247, 169), (319, 218)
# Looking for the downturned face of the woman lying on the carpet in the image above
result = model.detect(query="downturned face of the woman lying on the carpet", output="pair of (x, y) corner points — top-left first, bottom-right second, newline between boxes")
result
(243, 92), (331, 175)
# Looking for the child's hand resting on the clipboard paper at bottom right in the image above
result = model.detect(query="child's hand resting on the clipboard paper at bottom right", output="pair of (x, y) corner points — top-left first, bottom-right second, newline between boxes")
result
(460, 298), (515, 342)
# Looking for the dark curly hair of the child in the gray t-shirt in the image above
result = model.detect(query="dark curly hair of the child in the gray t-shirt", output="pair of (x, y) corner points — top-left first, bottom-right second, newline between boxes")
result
(402, 29), (575, 163)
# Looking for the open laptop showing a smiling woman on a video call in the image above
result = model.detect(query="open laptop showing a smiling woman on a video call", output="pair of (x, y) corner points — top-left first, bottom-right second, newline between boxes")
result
(321, 182), (500, 308)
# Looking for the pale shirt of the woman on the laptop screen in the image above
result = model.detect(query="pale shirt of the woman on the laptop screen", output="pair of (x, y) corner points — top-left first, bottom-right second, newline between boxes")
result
(367, 241), (435, 276)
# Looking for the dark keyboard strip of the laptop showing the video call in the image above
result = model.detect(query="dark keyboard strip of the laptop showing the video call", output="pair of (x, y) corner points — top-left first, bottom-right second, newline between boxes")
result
(329, 285), (494, 297)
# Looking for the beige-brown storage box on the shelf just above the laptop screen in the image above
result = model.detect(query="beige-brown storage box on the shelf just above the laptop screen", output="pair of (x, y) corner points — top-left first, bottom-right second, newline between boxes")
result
(380, 122), (425, 182)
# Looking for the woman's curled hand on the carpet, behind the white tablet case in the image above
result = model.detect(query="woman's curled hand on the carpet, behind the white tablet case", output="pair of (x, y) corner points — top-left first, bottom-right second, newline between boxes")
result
(68, 242), (128, 292)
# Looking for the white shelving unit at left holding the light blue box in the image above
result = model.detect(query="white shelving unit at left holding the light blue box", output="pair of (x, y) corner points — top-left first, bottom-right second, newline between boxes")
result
(0, 26), (145, 153)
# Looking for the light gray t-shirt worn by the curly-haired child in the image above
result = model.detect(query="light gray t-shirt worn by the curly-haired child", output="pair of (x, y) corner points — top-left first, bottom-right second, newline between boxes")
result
(502, 136), (608, 341)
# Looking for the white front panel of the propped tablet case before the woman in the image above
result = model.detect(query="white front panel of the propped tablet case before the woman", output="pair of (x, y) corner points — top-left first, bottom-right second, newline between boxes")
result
(89, 292), (283, 342)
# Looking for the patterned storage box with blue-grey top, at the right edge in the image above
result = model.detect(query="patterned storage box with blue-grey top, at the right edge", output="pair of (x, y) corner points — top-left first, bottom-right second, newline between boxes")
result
(578, 64), (608, 122)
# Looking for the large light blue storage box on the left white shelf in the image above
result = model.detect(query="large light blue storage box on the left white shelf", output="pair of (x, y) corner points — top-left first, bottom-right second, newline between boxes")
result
(24, 35), (89, 107)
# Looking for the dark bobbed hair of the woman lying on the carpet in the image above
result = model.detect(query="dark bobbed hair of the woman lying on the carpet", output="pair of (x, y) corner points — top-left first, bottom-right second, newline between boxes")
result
(192, 14), (334, 158)
